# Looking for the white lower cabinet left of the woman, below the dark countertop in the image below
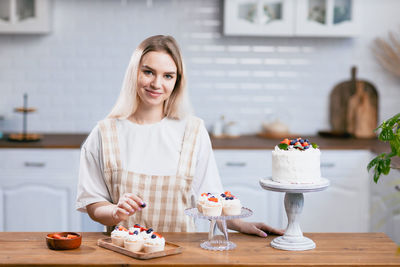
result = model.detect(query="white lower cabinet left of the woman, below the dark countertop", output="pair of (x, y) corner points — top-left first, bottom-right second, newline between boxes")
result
(0, 149), (103, 232)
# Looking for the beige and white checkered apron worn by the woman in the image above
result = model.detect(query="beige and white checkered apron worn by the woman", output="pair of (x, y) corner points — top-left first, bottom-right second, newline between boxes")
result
(99, 117), (201, 232)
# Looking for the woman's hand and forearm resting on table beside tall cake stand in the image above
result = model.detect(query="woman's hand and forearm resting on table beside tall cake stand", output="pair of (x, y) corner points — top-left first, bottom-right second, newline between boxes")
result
(228, 220), (285, 237)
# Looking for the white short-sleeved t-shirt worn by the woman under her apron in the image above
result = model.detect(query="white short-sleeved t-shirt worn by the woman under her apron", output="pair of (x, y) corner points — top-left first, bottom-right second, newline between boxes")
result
(76, 118), (223, 212)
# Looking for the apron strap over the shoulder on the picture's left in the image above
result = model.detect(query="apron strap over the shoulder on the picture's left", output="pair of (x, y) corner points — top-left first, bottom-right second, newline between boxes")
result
(99, 119), (121, 173)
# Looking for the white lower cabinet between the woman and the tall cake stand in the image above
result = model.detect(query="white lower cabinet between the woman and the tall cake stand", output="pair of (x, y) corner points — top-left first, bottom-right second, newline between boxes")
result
(215, 150), (284, 228)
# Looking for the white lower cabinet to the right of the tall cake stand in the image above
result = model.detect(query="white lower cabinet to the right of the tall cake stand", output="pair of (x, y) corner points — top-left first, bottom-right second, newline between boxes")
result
(300, 150), (371, 232)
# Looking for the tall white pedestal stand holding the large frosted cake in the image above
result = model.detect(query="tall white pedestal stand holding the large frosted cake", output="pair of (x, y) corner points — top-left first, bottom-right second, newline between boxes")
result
(260, 178), (330, 251)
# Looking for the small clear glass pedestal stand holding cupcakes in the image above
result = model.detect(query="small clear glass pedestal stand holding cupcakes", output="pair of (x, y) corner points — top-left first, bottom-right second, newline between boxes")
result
(185, 208), (253, 251)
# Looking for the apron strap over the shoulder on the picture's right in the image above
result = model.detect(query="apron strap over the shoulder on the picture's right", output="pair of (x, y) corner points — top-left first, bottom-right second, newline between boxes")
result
(177, 116), (202, 177)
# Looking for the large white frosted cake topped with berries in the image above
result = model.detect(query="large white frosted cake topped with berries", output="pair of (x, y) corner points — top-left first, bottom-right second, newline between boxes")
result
(272, 138), (321, 184)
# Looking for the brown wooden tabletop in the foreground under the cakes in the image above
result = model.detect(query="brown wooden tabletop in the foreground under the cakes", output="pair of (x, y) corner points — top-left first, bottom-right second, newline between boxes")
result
(0, 232), (400, 267)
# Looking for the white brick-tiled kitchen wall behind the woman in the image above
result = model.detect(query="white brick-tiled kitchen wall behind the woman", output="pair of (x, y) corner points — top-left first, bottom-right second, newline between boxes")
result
(0, 0), (400, 134)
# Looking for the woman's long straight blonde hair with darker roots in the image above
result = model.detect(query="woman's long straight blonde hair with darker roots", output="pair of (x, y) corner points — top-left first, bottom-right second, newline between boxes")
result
(107, 35), (191, 120)
